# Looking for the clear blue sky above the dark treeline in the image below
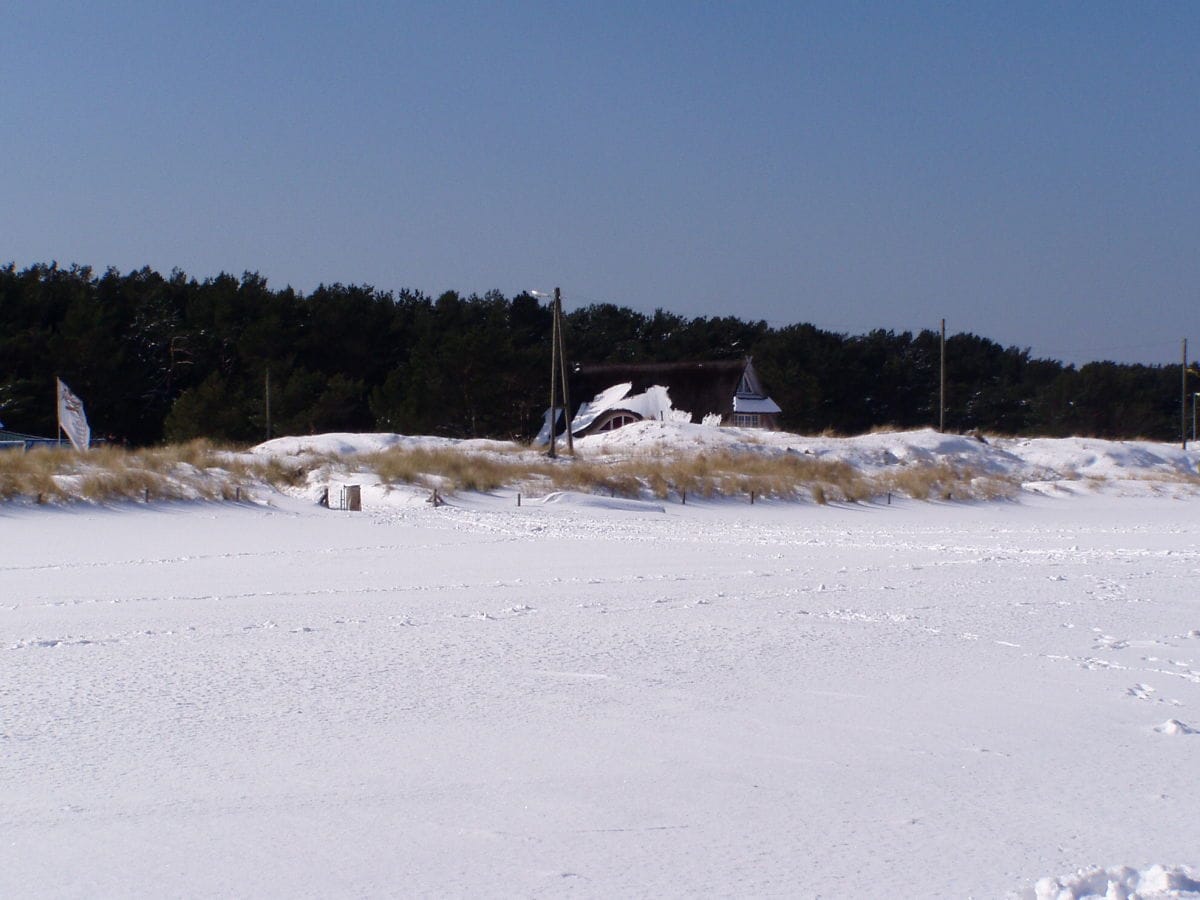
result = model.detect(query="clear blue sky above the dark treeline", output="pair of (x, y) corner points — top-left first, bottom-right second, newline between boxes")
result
(0, 0), (1200, 362)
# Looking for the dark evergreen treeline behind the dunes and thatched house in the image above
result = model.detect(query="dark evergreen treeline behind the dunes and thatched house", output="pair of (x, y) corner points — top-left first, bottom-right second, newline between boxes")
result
(0, 264), (1180, 445)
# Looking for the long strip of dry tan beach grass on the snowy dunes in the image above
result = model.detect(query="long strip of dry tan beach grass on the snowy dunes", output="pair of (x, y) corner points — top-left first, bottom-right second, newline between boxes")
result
(0, 440), (1020, 504)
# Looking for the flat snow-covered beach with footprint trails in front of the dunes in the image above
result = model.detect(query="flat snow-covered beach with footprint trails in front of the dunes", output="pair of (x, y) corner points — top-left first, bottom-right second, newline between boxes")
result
(0, 437), (1200, 898)
